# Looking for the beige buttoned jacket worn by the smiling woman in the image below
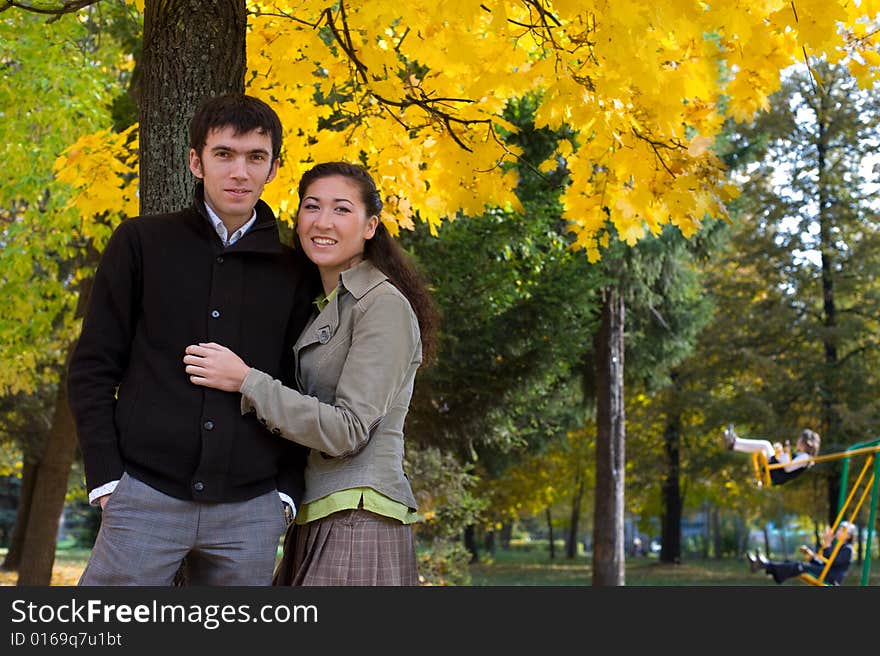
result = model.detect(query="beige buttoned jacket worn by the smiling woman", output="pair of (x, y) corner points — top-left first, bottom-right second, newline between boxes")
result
(241, 261), (422, 509)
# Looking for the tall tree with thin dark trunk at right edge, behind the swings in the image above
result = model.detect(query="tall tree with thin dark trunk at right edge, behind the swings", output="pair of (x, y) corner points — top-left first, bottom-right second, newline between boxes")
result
(716, 65), (880, 521)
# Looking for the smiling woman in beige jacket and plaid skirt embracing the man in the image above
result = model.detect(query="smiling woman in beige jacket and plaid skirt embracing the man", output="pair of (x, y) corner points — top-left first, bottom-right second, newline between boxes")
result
(184, 162), (436, 585)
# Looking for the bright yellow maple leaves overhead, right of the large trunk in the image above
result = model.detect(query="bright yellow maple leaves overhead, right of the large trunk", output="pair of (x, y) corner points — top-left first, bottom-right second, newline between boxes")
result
(75, 0), (880, 260)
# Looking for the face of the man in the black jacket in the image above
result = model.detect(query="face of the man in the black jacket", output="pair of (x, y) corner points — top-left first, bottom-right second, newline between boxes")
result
(189, 126), (278, 230)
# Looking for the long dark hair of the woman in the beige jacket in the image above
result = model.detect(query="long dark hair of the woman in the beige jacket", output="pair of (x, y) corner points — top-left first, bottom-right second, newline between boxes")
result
(297, 162), (440, 364)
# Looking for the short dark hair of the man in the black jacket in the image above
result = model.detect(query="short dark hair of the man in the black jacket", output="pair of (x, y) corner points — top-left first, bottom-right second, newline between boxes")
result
(189, 93), (281, 160)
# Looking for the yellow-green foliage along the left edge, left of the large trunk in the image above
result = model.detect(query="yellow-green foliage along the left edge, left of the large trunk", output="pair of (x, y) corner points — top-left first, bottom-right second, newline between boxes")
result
(0, 11), (134, 393)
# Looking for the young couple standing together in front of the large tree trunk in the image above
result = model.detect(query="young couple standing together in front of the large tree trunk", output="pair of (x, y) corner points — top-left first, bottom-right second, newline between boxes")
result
(68, 95), (436, 586)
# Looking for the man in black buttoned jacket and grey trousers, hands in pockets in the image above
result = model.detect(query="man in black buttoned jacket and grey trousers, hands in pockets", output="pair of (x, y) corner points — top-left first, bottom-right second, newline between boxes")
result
(68, 94), (315, 585)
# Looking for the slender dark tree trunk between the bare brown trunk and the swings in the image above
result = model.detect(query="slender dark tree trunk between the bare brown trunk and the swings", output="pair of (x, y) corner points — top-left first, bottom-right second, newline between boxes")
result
(660, 380), (682, 563)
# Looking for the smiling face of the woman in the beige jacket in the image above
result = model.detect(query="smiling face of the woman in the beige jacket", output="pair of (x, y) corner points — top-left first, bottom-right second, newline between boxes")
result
(296, 175), (379, 288)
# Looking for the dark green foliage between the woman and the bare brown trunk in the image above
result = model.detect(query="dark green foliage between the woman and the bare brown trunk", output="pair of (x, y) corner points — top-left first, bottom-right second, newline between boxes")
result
(401, 101), (594, 459)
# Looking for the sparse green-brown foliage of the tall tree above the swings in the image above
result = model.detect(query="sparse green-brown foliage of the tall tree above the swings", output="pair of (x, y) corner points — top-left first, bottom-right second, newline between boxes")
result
(703, 60), (880, 452)
